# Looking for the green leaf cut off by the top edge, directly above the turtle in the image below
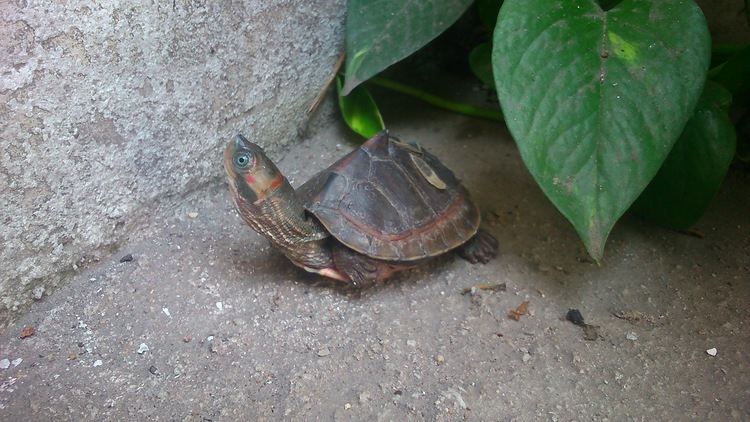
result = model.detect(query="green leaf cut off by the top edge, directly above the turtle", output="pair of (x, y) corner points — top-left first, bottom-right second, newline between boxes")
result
(344, 0), (472, 95)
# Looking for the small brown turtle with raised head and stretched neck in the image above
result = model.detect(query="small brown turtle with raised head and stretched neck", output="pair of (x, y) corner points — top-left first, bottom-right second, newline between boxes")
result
(224, 131), (498, 288)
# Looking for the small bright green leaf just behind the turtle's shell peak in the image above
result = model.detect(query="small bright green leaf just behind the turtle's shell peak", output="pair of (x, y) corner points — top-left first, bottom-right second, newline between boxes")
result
(336, 75), (385, 139)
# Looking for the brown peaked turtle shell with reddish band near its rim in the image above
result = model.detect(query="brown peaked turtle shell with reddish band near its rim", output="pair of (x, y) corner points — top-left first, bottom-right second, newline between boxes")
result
(298, 132), (480, 261)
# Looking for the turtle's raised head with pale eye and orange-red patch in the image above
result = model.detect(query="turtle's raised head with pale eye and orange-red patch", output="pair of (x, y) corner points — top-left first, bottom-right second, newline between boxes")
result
(224, 135), (286, 205)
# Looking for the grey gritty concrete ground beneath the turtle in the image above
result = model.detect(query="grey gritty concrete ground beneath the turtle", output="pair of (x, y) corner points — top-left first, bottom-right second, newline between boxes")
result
(0, 93), (750, 421)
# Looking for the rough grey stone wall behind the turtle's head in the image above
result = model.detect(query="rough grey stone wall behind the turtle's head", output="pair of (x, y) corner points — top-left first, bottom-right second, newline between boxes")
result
(0, 0), (344, 325)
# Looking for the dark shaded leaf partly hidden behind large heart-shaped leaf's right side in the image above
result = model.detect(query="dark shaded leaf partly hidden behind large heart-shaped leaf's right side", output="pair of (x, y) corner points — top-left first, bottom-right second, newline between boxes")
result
(631, 82), (736, 229)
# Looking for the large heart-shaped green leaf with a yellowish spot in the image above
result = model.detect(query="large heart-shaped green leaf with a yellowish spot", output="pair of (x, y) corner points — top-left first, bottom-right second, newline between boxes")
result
(492, 0), (710, 261)
